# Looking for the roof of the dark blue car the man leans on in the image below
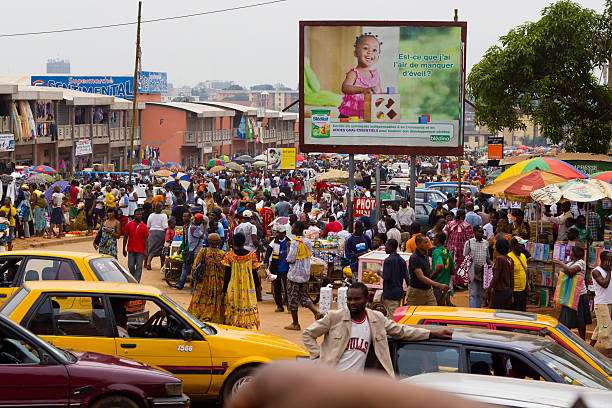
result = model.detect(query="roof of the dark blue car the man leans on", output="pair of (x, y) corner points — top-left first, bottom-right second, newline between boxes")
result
(421, 326), (556, 352)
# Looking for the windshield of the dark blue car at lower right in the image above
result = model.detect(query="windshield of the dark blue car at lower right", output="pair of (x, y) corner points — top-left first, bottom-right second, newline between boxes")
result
(532, 343), (612, 390)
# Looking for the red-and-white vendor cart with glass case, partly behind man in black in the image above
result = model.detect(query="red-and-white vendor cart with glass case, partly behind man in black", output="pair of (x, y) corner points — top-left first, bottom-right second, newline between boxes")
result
(357, 251), (411, 316)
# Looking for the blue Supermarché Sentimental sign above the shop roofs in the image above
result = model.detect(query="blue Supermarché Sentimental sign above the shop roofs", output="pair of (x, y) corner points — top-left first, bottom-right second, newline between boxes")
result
(31, 71), (168, 99)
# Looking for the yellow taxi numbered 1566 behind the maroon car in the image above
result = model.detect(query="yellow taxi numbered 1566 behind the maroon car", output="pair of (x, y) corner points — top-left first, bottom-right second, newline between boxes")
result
(0, 281), (308, 399)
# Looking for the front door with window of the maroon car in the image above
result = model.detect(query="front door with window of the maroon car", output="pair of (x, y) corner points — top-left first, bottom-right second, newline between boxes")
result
(0, 325), (69, 407)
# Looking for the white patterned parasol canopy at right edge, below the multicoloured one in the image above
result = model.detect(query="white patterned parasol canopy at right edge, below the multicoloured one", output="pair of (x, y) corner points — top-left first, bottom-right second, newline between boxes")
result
(531, 179), (612, 205)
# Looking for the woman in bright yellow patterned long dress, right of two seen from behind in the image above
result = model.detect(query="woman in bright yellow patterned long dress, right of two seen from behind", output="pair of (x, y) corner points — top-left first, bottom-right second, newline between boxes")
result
(223, 233), (260, 329)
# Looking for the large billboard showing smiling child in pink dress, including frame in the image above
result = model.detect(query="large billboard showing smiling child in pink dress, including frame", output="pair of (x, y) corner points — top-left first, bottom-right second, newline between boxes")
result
(300, 21), (467, 155)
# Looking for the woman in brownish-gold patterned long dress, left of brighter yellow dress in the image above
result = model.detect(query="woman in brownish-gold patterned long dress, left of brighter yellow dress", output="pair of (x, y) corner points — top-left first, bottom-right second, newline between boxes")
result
(189, 233), (225, 324)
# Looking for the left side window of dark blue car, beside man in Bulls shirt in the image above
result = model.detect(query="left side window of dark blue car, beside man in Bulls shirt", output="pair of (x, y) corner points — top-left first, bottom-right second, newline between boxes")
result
(392, 342), (462, 378)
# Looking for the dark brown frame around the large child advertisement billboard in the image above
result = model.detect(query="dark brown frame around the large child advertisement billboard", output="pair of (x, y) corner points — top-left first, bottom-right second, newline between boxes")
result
(298, 20), (467, 156)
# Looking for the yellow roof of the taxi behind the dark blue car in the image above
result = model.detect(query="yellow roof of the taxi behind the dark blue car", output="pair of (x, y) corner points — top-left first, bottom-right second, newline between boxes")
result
(411, 306), (559, 327)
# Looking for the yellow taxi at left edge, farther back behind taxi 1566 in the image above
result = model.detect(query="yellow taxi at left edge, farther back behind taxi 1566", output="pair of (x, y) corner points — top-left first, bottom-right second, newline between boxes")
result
(0, 250), (136, 304)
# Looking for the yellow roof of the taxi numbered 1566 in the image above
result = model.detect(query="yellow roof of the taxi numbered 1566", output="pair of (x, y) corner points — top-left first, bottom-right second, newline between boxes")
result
(23, 280), (162, 296)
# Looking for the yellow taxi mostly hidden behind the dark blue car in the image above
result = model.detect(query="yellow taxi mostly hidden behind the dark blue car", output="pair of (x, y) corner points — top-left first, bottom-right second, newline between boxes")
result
(393, 306), (612, 381)
